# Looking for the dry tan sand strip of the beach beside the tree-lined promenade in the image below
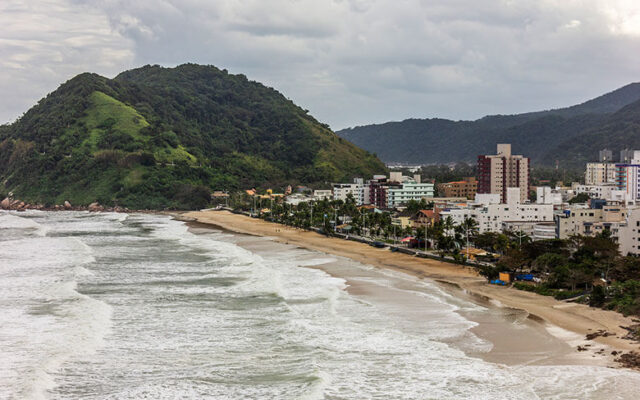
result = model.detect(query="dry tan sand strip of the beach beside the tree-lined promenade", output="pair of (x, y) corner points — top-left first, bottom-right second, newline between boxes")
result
(181, 211), (640, 362)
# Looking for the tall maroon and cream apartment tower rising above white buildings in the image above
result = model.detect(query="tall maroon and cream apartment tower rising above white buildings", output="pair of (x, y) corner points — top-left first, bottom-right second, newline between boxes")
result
(477, 144), (530, 203)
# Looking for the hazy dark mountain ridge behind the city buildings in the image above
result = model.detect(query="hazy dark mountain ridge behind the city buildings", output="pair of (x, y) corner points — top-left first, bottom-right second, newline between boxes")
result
(337, 83), (640, 167)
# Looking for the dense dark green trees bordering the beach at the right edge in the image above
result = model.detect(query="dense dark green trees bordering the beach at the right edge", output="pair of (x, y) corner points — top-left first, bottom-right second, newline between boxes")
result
(474, 231), (640, 316)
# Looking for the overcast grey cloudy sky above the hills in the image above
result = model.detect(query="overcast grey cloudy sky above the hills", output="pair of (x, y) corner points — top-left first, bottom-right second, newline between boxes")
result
(0, 0), (640, 129)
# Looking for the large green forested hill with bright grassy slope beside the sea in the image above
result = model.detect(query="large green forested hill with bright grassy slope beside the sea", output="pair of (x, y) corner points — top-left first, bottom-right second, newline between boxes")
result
(0, 64), (385, 209)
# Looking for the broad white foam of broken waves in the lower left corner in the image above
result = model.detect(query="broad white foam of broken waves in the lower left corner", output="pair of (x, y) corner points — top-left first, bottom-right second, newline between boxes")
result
(0, 236), (111, 399)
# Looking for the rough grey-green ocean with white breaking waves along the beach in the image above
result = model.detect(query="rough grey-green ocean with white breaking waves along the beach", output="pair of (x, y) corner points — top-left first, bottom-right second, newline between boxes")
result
(0, 211), (640, 400)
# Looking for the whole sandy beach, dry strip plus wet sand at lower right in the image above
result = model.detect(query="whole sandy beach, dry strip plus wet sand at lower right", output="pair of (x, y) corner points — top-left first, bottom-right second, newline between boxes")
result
(182, 211), (640, 365)
